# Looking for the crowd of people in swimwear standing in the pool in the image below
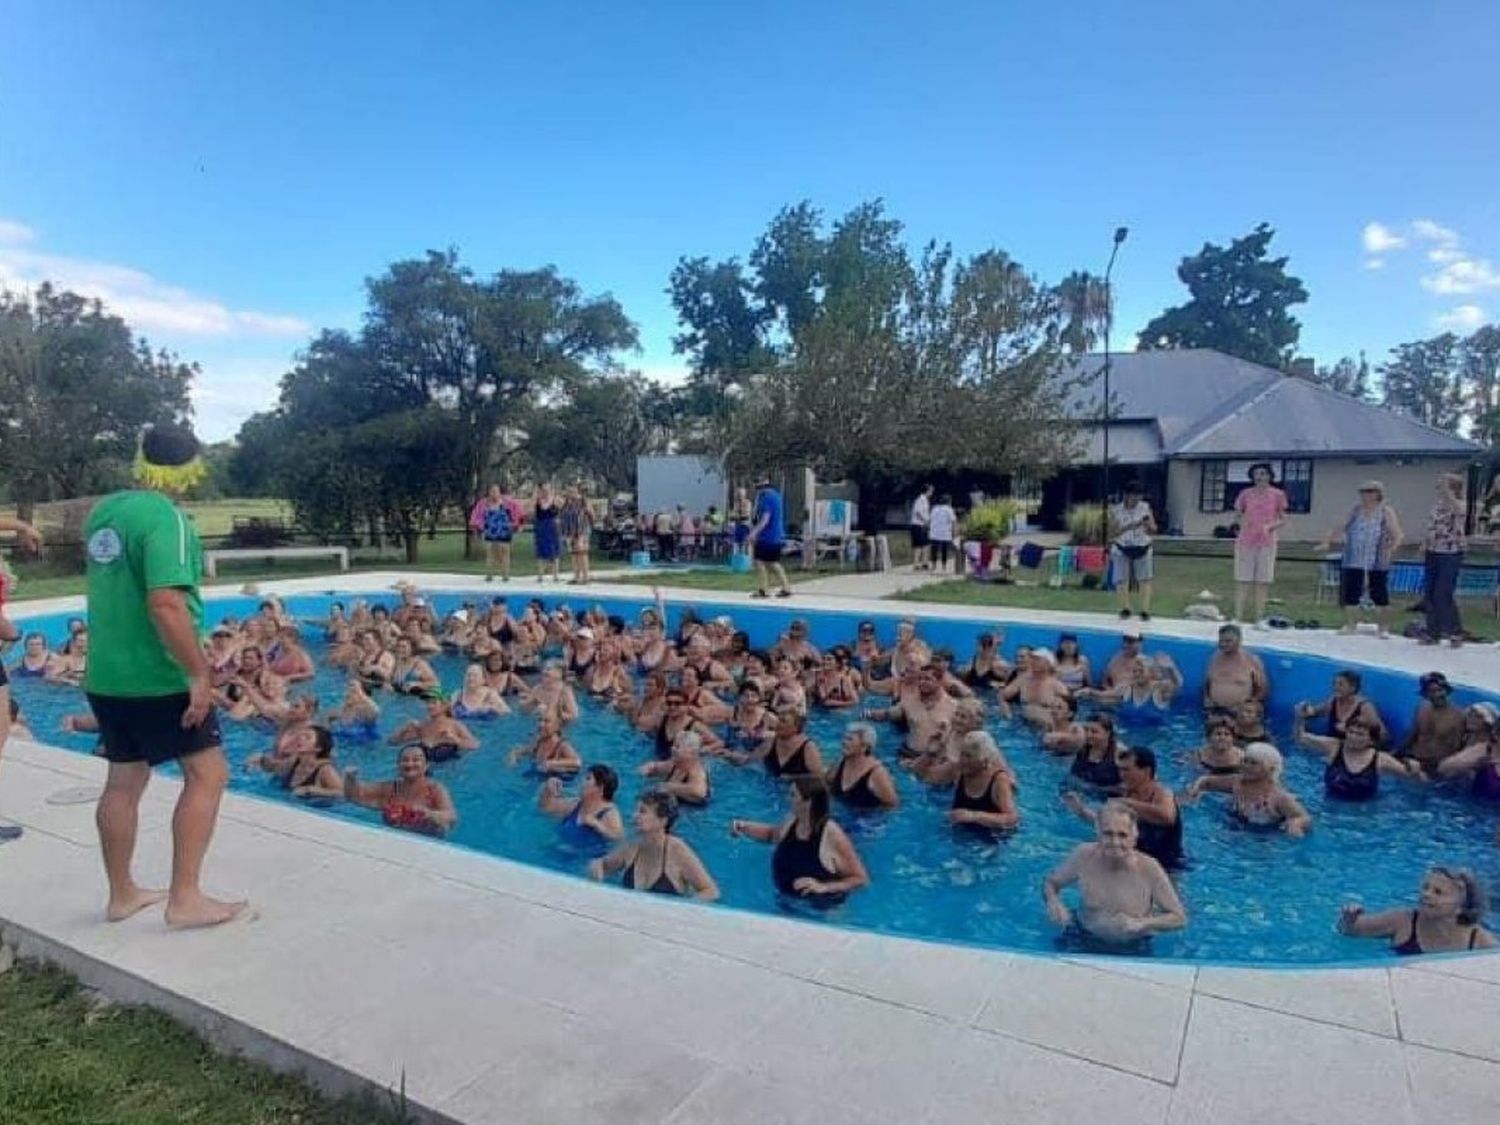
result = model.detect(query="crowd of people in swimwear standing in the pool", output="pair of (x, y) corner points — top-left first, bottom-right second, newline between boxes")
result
(11, 587), (1500, 954)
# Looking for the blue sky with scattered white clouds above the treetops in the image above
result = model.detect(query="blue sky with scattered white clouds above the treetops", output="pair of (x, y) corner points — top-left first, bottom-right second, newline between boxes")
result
(0, 0), (1500, 438)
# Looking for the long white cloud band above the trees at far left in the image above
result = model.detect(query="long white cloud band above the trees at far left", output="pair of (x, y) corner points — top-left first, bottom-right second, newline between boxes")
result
(0, 219), (312, 338)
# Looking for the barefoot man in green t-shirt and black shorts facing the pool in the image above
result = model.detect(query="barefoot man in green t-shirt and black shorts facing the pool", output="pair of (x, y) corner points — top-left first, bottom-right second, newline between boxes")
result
(84, 426), (246, 929)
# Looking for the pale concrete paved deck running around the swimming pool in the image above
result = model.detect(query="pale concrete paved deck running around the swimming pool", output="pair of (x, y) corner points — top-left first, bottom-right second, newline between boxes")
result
(0, 575), (1500, 1125)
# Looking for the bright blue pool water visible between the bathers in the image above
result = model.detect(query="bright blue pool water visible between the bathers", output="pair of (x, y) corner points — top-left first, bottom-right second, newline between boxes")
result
(14, 594), (1500, 963)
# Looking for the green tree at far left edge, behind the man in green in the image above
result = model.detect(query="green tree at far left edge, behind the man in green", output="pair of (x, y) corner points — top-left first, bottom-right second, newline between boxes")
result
(0, 284), (198, 519)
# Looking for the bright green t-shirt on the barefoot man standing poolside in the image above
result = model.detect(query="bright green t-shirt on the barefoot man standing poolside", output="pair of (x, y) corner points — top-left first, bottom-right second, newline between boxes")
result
(84, 489), (203, 698)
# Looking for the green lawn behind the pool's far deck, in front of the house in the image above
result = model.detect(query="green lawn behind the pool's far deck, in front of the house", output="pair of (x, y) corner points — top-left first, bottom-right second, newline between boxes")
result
(900, 552), (1500, 641)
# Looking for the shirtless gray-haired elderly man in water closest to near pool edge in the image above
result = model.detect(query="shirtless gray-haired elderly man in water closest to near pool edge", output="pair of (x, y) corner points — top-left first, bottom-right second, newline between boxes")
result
(1043, 801), (1188, 947)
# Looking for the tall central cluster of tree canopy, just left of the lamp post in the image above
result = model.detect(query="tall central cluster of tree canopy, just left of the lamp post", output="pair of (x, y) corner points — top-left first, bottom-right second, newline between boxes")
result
(669, 201), (1097, 507)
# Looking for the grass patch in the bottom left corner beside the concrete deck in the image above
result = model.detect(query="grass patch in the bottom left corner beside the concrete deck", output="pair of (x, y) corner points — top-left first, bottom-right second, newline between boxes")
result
(0, 963), (410, 1125)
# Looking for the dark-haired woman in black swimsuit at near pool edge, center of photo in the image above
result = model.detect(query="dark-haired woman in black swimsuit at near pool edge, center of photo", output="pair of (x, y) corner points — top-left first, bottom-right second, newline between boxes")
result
(729, 776), (870, 906)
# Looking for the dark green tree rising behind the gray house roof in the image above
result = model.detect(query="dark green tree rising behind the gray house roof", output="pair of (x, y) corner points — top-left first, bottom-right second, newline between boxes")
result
(1140, 224), (1308, 368)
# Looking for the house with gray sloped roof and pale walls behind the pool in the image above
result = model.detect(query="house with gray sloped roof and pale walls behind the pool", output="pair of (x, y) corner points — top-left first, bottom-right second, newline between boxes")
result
(1043, 348), (1482, 540)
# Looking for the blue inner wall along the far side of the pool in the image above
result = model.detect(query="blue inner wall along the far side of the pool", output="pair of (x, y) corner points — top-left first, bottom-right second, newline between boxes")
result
(17, 588), (1500, 740)
